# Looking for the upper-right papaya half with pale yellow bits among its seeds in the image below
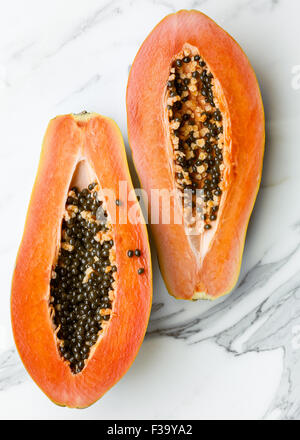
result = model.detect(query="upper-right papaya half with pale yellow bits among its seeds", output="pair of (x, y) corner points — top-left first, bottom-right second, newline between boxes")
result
(127, 10), (265, 300)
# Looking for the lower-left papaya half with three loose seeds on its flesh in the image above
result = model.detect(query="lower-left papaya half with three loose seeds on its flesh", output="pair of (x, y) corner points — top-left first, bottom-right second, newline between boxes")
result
(11, 112), (152, 408)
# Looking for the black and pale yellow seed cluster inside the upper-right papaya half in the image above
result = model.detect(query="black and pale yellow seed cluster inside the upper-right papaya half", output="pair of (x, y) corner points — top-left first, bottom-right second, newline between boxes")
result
(166, 48), (225, 231)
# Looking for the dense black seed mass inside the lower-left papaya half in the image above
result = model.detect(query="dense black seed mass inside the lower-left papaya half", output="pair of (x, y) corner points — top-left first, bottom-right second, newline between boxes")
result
(50, 182), (117, 374)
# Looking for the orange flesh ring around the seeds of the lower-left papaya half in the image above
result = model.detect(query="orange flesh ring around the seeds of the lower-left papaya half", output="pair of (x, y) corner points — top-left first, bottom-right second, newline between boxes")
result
(11, 113), (152, 408)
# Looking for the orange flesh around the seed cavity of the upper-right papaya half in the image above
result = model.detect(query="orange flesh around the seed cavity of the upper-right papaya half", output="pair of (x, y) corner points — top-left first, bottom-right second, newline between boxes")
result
(127, 10), (265, 300)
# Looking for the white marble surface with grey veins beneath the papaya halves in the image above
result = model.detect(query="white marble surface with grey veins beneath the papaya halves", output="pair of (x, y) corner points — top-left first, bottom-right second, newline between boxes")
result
(0, 0), (300, 419)
